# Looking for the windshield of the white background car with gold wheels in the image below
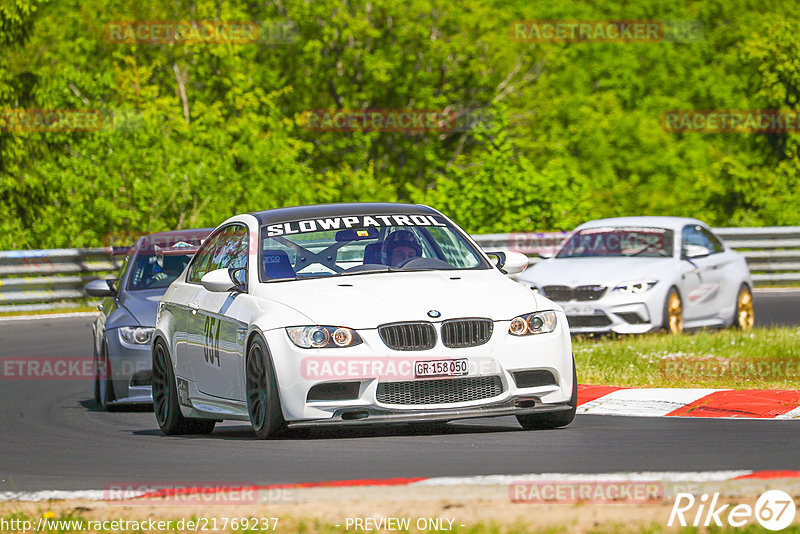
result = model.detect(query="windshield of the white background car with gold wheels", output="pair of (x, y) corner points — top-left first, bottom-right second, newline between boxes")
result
(556, 227), (673, 258)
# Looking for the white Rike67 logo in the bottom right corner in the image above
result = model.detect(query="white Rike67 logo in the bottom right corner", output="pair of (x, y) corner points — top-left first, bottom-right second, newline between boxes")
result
(667, 490), (797, 531)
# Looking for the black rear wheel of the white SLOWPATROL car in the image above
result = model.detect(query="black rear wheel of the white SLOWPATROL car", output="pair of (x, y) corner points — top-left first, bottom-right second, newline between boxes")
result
(153, 340), (216, 436)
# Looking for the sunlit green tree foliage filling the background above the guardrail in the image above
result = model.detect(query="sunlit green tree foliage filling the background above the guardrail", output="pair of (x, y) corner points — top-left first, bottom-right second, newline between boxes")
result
(0, 0), (800, 249)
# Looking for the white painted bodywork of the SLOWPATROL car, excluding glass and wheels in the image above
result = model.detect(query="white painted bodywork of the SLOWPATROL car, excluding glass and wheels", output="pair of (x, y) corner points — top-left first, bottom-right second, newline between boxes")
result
(155, 208), (574, 426)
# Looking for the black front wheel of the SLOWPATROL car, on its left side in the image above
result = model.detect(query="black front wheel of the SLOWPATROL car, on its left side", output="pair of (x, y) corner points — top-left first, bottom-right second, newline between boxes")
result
(245, 337), (286, 439)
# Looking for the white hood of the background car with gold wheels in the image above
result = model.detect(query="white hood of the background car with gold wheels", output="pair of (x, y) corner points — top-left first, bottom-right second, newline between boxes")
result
(519, 258), (675, 287)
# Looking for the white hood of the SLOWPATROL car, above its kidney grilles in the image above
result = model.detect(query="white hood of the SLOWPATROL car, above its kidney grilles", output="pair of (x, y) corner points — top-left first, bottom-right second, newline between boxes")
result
(256, 270), (537, 329)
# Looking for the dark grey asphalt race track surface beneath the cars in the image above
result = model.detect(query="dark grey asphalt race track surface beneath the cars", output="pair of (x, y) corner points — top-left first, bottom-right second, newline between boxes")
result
(0, 292), (800, 491)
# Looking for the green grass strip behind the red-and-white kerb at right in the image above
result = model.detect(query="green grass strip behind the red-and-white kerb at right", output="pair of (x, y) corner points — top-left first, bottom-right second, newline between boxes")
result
(573, 327), (800, 389)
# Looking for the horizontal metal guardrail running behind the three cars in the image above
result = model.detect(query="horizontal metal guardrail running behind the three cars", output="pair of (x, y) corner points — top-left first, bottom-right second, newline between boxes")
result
(0, 226), (800, 312)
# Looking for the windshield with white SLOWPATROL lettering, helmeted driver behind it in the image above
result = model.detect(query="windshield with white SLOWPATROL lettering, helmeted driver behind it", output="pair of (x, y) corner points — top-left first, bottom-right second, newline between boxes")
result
(259, 215), (491, 281)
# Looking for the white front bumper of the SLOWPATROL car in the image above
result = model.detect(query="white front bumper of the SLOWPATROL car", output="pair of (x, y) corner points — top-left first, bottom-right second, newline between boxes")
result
(264, 312), (573, 426)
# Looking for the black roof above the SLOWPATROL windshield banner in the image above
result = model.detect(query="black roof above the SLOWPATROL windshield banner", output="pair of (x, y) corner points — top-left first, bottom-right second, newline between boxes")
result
(251, 202), (439, 226)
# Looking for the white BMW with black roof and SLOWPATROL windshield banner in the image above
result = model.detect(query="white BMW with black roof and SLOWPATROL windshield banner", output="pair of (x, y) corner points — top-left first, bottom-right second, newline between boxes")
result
(152, 204), (577, 439)
